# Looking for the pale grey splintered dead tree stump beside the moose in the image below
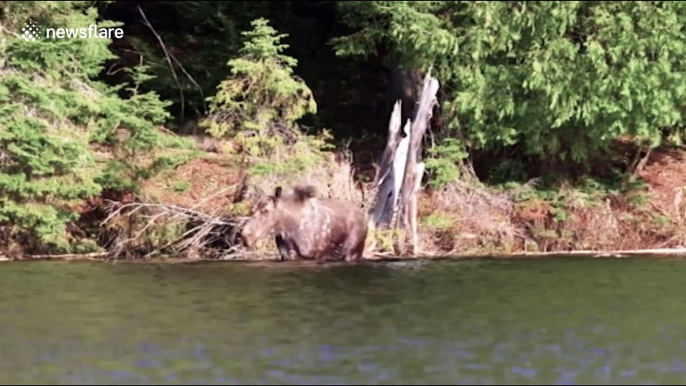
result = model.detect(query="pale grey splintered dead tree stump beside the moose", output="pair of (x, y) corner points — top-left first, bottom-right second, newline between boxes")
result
(369, 69), (439, 255)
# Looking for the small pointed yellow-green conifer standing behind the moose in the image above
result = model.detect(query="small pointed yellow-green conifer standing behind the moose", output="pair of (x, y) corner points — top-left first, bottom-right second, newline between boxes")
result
(201, 18), (317, 143)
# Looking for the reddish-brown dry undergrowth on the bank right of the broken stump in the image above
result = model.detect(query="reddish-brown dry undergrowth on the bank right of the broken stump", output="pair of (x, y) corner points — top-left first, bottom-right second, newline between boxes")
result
(420, 164), (686, 255)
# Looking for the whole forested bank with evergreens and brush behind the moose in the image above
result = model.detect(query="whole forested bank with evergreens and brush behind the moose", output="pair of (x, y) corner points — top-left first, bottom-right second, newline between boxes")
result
(0, 1), (686, 258)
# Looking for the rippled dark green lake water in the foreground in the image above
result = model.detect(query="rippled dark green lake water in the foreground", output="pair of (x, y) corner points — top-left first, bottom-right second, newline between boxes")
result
(0, 260), (686, 385)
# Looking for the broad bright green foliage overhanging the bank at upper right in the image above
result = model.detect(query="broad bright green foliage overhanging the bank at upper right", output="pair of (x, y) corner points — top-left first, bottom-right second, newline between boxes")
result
(333, 1), (686, 179)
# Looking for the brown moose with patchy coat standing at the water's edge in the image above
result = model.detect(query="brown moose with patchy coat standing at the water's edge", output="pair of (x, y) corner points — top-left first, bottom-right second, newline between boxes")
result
(241, 185), (367, 261)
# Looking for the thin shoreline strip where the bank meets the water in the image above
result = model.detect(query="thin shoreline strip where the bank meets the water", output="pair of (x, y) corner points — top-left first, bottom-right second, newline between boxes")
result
(0, 248), (686, 266)
